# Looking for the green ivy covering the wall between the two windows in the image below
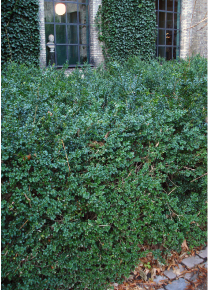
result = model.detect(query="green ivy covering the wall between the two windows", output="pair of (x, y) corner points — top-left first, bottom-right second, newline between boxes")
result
(97, 0), (156, 61)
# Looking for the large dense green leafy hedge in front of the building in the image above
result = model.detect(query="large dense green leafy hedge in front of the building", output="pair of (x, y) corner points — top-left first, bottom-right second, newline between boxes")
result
(2, 58), (208, 290)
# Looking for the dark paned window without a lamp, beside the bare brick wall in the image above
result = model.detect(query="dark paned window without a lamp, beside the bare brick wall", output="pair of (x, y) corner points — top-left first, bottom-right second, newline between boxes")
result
(156, 0), (181, 60)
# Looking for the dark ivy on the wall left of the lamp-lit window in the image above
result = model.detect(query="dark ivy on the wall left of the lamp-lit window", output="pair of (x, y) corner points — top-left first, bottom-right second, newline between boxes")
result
(1, 0), (40, 64)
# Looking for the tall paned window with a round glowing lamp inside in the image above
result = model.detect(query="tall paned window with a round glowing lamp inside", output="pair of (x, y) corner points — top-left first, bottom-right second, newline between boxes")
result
(44, 0), (89, 67)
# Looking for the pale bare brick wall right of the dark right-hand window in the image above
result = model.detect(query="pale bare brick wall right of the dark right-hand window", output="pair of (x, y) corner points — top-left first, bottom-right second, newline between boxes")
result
(180, 0), (208, 58)
